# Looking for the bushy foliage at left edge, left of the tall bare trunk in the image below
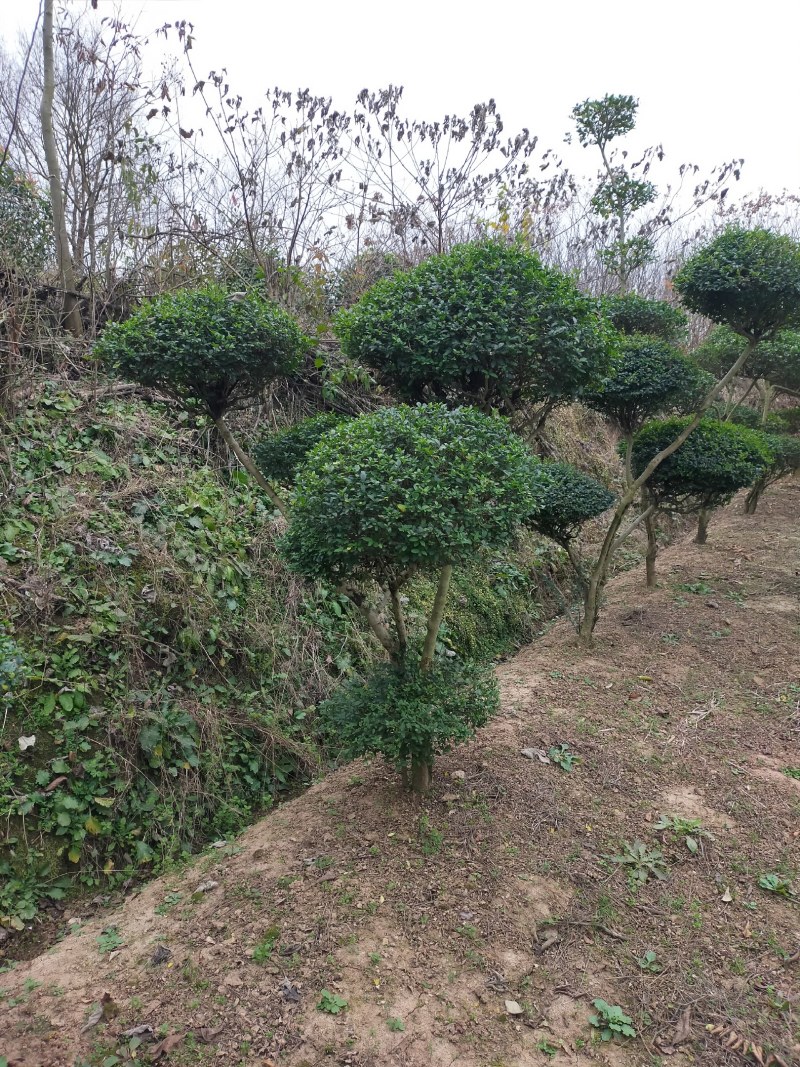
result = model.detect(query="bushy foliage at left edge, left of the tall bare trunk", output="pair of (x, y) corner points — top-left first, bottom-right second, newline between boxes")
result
(0, 159), (52, 276)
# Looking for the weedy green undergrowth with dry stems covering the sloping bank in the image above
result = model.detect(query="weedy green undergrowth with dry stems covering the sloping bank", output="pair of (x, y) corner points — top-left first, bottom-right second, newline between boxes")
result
(0, 381), (558, 927)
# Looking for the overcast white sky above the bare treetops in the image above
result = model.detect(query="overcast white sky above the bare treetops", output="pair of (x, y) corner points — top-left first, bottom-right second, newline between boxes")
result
(0, 0), (800, 193)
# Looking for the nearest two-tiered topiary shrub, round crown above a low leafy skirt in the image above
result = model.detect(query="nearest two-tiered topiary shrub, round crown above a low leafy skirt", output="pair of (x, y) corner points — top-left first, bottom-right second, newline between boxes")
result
(281, 404), (545, 792)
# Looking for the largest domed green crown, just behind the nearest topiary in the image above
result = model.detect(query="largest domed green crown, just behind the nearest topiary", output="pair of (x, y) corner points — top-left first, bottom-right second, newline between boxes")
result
(335, 242), (612, 412)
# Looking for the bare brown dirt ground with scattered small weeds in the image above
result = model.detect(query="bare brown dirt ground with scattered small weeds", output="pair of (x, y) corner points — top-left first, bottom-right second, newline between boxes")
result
(0, 481), (800, 1067)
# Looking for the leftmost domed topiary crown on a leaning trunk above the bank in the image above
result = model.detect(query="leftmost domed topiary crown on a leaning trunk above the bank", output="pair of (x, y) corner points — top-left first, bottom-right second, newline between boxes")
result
(94, 286), (310, 418)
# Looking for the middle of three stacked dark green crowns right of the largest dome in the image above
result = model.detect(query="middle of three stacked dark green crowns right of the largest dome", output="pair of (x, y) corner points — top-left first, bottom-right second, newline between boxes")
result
(582, 334), (713, 433)
